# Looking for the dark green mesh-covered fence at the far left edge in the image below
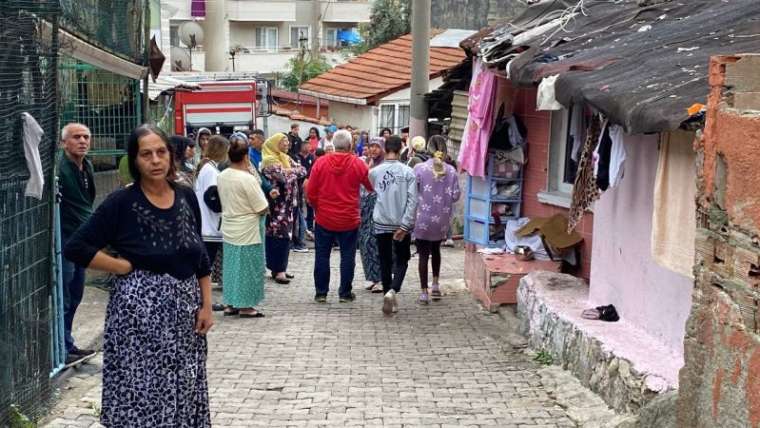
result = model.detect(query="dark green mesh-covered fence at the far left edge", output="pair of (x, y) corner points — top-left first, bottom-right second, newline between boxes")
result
(0, 0), (59, 426)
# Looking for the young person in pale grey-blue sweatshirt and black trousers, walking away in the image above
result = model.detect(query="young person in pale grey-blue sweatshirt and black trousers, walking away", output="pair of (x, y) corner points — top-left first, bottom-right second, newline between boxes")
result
(369, 136), (417, 315)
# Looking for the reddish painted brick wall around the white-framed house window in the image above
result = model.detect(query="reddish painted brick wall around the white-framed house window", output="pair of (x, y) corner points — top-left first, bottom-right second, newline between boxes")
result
(514, 88), (594, 280)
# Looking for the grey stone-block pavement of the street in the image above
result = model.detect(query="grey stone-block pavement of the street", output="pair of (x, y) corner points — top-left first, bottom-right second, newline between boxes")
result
(43, 249), (615, 428)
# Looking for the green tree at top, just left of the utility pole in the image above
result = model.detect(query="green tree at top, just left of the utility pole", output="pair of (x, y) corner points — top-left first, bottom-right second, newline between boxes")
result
(362, 0), (412, 50)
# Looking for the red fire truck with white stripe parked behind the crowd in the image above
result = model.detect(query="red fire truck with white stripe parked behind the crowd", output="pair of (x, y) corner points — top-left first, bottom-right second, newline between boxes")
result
(174, 80), (271, 135)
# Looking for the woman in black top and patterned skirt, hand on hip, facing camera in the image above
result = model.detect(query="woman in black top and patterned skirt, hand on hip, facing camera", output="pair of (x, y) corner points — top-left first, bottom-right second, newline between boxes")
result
(64, 125), (213, 427)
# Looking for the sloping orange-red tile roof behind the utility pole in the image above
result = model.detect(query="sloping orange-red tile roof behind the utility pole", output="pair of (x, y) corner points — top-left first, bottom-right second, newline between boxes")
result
(298, 34), (465, 104)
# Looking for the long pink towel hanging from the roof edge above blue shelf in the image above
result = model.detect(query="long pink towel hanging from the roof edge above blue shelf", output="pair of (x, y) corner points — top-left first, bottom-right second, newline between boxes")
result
(458, 58), (498, 177)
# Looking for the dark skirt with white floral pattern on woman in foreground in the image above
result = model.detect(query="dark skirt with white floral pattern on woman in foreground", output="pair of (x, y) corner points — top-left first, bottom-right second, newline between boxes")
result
(100, 270), (211, 428)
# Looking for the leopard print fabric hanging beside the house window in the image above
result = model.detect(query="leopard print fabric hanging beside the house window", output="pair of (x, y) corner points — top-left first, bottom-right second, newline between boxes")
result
(567, 118), (602, 233)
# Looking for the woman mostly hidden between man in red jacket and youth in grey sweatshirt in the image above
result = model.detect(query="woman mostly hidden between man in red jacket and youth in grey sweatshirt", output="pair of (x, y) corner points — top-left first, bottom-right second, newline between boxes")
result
(359, 137), (385, 293)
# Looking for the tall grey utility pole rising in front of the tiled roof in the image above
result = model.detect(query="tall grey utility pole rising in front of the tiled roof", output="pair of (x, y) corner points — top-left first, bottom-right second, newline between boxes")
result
(409, 0), (431, 139)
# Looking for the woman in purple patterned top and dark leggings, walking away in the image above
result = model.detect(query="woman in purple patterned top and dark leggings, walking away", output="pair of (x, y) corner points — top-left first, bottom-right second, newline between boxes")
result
(414, 135), (460, 304)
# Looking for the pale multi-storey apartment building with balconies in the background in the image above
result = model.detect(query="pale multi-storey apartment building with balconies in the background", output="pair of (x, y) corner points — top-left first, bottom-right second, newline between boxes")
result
(155, 0), (372, 75)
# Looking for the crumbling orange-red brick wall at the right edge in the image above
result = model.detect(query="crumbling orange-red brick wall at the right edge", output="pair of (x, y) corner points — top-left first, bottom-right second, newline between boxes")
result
(678, 55), (760, 428)
